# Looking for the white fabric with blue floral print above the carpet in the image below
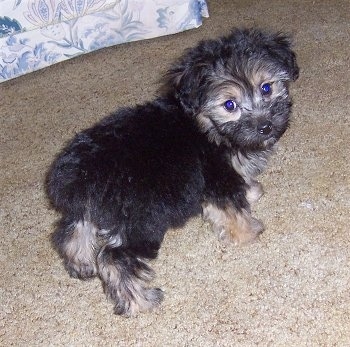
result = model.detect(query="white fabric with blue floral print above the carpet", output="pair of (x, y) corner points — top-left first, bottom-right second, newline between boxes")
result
(0, 0), (208, 82)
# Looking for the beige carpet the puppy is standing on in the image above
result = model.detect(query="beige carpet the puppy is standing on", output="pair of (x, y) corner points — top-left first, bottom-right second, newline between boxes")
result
(0, 0), (350, 347)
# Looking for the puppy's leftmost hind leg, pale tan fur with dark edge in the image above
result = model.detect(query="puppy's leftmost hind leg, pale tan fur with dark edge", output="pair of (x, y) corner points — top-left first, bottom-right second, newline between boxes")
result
(52, 219), (98, 279)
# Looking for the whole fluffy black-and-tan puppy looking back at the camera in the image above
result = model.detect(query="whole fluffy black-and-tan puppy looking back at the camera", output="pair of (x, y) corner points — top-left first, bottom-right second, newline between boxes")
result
(47, 29), (299, 316)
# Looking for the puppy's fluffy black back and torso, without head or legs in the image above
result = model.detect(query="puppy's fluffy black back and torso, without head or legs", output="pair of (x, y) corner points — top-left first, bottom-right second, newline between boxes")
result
(48, 99), (204, 245)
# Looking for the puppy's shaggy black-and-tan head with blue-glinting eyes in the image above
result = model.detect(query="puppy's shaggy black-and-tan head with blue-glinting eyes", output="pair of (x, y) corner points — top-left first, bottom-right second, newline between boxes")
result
(163, 29), (299, 150)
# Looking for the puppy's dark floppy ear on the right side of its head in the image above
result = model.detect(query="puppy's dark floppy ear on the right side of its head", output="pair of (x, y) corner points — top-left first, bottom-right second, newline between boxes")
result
(265, 33), (299, 81)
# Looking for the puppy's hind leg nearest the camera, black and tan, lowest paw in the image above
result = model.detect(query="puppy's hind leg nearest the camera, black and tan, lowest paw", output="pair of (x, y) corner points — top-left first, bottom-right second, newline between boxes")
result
(97, 242), (163, 317)
